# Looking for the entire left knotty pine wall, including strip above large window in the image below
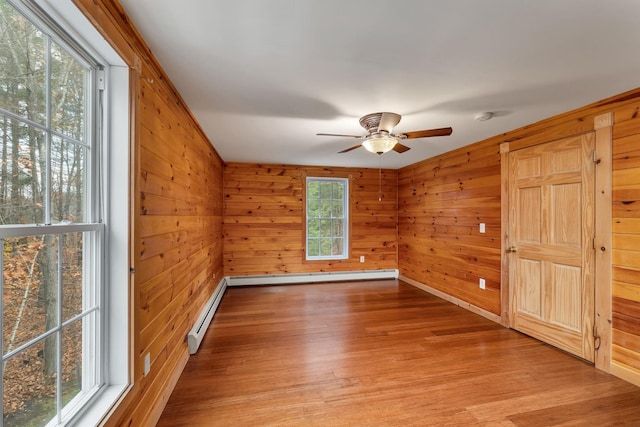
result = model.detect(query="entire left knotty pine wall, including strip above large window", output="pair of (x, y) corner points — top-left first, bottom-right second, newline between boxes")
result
(76, 0), (223, 426)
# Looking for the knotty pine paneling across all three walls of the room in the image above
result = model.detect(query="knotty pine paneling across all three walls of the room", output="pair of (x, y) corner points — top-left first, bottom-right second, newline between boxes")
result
(74, 0), (640, 426)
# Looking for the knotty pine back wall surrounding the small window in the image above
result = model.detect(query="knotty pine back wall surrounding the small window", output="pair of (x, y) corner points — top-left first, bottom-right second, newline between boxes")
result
(224, 163), (397, 276)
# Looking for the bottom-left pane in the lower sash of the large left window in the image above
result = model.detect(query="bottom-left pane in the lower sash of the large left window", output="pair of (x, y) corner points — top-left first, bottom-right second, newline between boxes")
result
(2, 340), (56, 426)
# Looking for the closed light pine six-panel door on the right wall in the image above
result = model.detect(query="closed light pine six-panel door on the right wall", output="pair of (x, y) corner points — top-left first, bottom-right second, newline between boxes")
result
(507, 133), (595, 361)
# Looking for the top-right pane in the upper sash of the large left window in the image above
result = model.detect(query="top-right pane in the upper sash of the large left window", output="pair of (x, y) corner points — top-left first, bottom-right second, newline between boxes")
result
(51, 42), (87, 141)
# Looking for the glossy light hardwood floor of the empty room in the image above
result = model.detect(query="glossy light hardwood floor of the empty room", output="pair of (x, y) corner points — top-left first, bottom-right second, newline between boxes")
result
(158, 280), (640, 427)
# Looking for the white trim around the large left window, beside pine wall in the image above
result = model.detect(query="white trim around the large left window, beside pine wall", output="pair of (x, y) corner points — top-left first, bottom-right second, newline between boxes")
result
(21, 0), (132, 426)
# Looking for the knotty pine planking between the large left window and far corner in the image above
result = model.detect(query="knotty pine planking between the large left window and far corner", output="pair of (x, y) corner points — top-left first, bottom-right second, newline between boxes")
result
(134, 72), (223, 425)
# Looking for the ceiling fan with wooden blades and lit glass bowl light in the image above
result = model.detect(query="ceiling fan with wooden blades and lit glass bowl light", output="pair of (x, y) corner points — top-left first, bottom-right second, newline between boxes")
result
(316, 113), (453, 154)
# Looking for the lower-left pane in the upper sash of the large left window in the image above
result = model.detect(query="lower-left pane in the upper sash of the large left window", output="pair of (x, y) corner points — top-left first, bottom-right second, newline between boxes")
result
(0, 115), (46, 224)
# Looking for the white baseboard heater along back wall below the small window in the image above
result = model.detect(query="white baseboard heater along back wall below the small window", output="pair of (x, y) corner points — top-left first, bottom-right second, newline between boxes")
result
(226, 269), (398, 286)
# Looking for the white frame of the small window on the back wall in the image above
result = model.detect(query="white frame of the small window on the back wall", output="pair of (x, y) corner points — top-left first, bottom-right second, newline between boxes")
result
(304, 176), (351, 262)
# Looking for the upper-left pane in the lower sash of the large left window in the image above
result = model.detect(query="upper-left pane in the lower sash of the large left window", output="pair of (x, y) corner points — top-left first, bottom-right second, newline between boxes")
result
(3, 234), (58, 354)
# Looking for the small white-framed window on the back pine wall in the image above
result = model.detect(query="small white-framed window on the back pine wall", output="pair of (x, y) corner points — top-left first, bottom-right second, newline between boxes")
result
(306, 177), (349, 260)
